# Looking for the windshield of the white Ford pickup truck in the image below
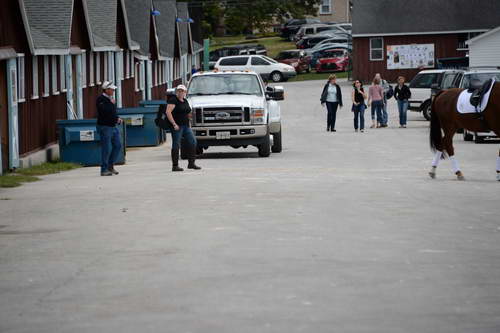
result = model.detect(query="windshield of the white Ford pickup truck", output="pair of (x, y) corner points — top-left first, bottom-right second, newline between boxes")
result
(188, 74), (262, 96)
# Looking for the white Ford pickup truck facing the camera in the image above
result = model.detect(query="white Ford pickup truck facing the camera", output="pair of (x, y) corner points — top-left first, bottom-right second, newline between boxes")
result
(180, 71), (284, 157)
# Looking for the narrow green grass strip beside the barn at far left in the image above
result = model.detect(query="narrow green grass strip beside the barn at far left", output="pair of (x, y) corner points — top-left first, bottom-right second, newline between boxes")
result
(0, 162), (81, 187)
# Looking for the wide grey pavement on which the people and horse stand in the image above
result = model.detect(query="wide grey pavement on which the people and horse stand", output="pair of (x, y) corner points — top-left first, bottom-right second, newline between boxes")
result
(0, 81), (500, 333)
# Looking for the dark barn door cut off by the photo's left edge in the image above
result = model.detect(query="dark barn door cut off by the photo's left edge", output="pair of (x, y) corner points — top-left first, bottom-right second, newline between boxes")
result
(0, 60), (9, 174)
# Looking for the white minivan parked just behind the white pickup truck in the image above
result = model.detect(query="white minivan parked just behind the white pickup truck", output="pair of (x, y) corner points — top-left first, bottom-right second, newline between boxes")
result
(215, 55), (297, 82)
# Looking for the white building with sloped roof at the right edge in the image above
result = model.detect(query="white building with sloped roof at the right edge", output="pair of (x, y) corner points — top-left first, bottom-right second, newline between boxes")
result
(466, 27), (500, 67)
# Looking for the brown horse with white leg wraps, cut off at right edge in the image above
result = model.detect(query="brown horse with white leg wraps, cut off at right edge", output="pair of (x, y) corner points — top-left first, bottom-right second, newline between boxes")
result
(429, 82), (500, 181)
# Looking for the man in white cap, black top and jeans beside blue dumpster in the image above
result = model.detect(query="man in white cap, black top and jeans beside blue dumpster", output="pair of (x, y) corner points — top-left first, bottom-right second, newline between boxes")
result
(96, 81), (122, 176)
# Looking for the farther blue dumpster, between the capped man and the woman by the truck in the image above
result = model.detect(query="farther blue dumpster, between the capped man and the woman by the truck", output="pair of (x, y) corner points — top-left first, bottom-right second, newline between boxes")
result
(117, 107), (162, 147)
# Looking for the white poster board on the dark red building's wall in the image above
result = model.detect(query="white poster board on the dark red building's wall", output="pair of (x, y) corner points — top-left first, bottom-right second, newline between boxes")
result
(387, 44), (434, 69)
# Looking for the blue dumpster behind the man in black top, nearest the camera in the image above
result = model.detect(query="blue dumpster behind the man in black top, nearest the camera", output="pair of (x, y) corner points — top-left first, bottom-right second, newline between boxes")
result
(56, 119), (126, 166)
